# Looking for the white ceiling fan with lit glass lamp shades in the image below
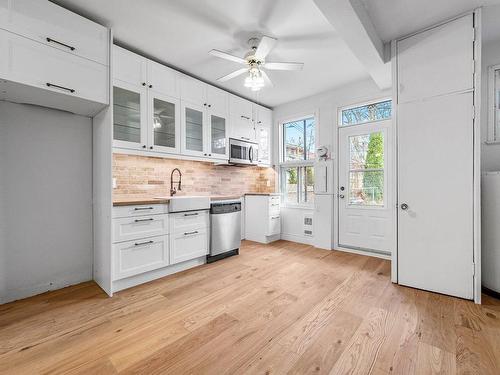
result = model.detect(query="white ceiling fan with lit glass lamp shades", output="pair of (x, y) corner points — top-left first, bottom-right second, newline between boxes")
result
(209, 36), (304, 91)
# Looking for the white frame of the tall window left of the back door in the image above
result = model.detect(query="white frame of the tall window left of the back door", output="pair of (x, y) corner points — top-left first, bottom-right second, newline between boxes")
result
(278, 112), (318, 209)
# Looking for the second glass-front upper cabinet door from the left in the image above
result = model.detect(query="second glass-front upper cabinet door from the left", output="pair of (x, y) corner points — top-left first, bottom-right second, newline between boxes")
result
(149, 92), (180, 153)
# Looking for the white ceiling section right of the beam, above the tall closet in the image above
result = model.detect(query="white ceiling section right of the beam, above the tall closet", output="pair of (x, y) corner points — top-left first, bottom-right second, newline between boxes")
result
(361, 0), (500, 42)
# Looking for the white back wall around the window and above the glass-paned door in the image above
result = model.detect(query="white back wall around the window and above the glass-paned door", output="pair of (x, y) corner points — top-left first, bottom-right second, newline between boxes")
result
(273, 79), (391, 248)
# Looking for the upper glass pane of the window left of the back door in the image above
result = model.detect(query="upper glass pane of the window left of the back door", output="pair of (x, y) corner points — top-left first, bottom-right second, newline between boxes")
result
(283, 118), (316, 162)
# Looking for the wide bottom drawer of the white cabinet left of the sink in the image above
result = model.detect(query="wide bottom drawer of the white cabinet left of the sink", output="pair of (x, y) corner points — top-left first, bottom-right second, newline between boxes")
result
(113, 236), (169, 280)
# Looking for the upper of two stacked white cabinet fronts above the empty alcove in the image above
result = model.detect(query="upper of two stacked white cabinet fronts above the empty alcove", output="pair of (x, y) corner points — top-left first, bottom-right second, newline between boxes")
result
(0, 0), (110, 65)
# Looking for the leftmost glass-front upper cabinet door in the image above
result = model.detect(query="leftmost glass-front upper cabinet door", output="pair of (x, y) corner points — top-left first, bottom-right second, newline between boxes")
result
(113, 82), (147, 149)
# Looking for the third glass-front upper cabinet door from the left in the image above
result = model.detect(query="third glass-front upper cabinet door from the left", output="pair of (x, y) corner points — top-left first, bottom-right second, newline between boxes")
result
(181, 102), (208, 156)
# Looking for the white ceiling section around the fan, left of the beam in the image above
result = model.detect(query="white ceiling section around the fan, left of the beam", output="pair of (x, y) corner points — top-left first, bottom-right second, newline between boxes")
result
(54, 0), (368, 107)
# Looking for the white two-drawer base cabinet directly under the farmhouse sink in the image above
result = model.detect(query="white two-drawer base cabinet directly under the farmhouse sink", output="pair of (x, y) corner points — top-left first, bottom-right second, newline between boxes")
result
(170, 210), (209, 264)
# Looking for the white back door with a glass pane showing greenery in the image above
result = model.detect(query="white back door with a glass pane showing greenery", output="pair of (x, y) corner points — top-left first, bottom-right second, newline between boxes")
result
(338, 120), (395, 255)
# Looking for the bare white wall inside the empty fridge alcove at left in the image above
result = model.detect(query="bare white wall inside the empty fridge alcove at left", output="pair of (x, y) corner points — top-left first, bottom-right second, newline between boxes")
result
(0, 101), (92, 303)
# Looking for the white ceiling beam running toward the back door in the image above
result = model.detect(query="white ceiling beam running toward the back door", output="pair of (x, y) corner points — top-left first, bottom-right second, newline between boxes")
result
(314, 0), (392, 89)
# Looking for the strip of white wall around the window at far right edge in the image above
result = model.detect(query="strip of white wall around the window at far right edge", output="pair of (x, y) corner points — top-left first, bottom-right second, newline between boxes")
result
(481, 39), (500, 171)
